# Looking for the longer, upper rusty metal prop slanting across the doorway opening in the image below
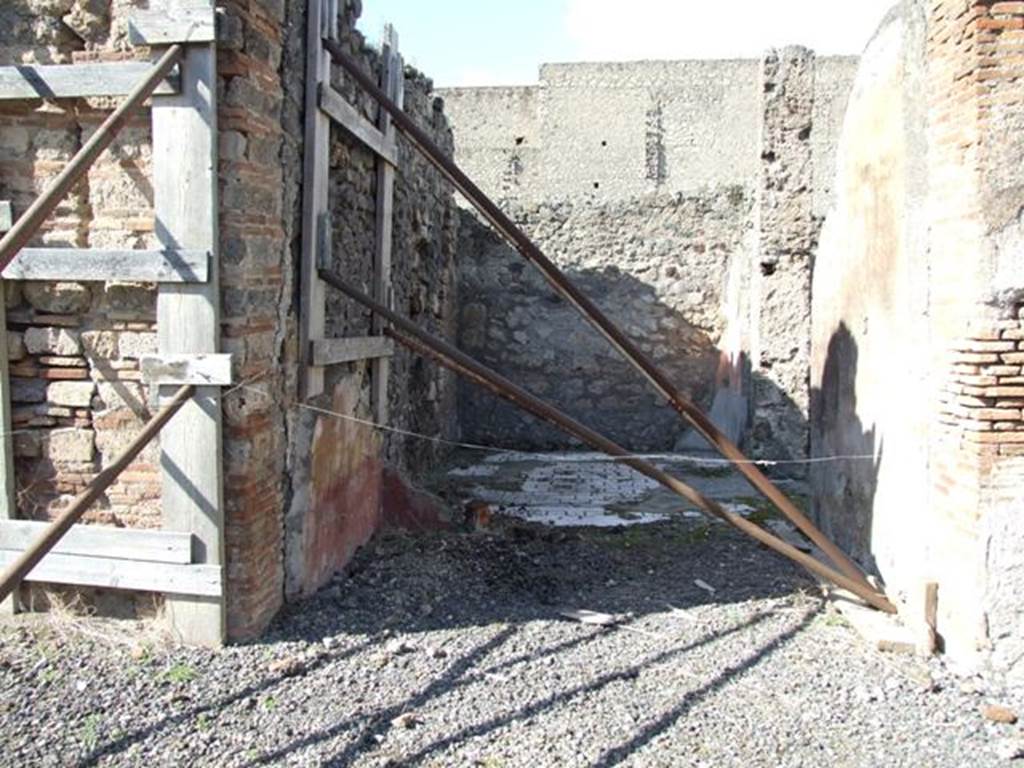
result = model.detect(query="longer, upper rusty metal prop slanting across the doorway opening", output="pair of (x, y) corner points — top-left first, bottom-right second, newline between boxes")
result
(324, 40), (871, 589)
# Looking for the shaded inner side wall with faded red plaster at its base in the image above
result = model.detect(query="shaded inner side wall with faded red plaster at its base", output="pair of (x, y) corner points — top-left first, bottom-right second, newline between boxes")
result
(285, 5), (459, 606)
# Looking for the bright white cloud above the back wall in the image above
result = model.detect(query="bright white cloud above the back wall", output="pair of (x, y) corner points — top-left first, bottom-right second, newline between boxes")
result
(564, 0), (894, 60)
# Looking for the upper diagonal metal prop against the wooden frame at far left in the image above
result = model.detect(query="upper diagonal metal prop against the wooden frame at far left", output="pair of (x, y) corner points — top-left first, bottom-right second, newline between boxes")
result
(0, 45), (183, 272)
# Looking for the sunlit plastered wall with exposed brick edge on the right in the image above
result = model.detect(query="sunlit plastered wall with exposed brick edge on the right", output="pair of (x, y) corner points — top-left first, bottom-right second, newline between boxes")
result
(812, 0), (1024, 680)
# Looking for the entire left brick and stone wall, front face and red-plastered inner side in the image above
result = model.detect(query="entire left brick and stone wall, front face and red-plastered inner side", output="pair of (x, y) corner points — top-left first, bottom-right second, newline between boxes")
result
(0, 0), (458, 638)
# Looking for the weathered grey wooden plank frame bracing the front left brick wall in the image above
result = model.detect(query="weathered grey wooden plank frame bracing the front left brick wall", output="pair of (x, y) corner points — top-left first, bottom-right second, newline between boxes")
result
(0, 0), (231, 645)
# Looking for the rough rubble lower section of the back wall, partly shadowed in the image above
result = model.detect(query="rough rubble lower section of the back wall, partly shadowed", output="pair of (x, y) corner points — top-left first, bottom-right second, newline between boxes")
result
(459, 187), (752, 451)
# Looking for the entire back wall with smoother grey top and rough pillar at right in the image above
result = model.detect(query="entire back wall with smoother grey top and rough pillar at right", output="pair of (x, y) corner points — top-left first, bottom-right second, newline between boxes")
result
(442, 55), (856, 459)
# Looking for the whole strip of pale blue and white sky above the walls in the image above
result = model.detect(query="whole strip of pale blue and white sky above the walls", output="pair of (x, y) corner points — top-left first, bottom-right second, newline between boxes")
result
(359, 0), (894, 86)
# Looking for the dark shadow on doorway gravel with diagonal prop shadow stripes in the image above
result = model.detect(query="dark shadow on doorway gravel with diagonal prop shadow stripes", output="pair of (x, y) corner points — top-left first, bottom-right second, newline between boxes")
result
(243, 523), (816, 766)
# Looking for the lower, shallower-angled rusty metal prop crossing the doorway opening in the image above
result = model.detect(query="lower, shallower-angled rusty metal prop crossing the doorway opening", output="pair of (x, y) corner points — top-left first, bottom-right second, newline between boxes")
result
(319, 269), (896, 613)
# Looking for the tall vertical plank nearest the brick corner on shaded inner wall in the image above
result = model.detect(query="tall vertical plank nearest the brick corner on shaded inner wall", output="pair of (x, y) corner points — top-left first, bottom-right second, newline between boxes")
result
(299, 0), (331, 399)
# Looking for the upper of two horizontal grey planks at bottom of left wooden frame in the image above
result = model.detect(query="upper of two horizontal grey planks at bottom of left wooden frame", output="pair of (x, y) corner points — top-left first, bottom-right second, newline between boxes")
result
(0, 520), (191, 565)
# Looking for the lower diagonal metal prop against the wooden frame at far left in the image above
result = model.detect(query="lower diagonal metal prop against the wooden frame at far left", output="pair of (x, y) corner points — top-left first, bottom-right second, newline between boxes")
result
(0, 384), (196, 601)
